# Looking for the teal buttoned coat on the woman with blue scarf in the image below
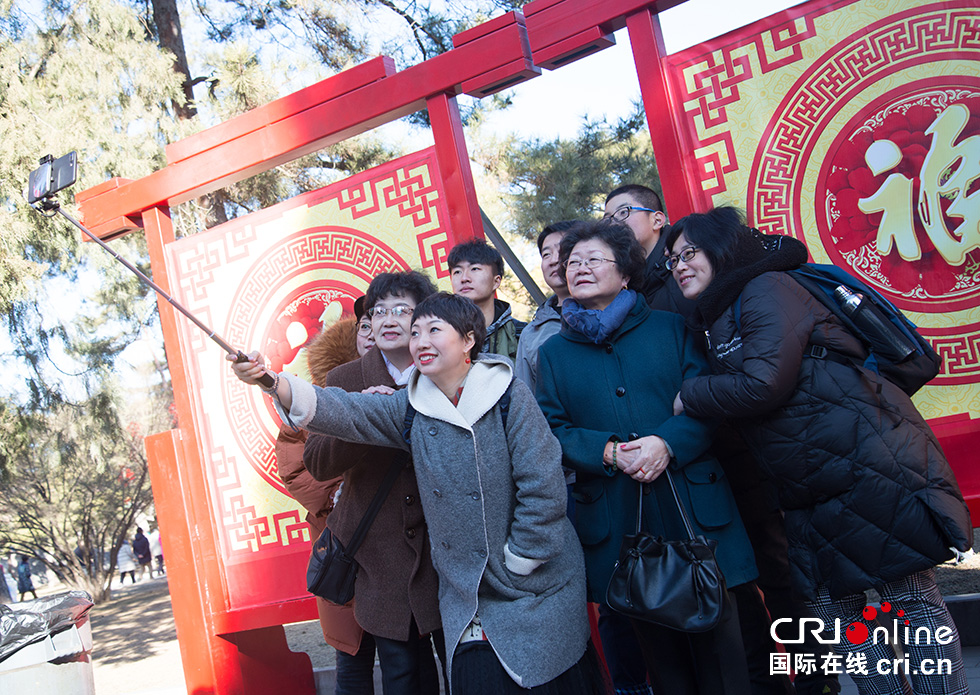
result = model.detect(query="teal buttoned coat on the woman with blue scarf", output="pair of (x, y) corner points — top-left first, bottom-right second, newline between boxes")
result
(537, 297), (758, 602)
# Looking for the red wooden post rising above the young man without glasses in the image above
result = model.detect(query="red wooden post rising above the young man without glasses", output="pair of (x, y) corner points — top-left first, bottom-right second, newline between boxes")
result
(425, 93), (483, 241)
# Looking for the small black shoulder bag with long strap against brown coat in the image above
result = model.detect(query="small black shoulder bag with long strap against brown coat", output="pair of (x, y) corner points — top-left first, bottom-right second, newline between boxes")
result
(306, 452), (408, 605)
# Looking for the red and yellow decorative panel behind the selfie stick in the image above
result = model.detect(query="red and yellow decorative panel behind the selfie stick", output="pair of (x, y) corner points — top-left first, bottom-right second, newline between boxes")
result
(167, 149), (454, 598)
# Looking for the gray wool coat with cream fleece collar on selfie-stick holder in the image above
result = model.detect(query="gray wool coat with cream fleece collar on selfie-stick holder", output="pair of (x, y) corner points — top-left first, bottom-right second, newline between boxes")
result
(272, 355), (589, 688)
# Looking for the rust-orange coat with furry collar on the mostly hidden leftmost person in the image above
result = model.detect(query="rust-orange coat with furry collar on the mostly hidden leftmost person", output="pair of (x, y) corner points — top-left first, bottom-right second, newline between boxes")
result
(276, 318), (364, 654)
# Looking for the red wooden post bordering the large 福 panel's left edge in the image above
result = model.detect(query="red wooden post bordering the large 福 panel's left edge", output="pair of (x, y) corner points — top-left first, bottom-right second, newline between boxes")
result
(626, 9), (695, 220)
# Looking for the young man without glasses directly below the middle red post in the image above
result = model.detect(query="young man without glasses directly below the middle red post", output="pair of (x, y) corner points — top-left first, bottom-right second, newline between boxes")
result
(447, 240), (527, 362)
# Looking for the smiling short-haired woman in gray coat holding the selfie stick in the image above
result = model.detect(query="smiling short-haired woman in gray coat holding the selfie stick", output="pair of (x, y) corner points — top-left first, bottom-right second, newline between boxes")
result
(229, 293), (602, 695)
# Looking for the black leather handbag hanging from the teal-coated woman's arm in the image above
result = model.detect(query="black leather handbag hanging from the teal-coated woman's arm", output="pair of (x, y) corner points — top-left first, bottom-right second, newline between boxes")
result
(606, 469), (727, 632)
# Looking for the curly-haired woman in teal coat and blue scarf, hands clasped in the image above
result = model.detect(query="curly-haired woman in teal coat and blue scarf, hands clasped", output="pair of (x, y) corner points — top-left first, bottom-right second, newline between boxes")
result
(537, 221), (756, 695)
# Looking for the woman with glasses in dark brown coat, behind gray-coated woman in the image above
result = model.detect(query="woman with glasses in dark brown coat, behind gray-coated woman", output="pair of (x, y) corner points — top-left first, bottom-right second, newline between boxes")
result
(303, 271), (445, 695)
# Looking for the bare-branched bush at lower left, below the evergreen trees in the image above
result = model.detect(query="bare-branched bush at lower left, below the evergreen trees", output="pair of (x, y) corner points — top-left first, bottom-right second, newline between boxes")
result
(0, 393), (167, 603)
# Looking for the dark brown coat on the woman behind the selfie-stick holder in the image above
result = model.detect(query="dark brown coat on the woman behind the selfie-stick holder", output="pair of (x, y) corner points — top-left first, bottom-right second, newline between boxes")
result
(303, 349), (442, 640)
